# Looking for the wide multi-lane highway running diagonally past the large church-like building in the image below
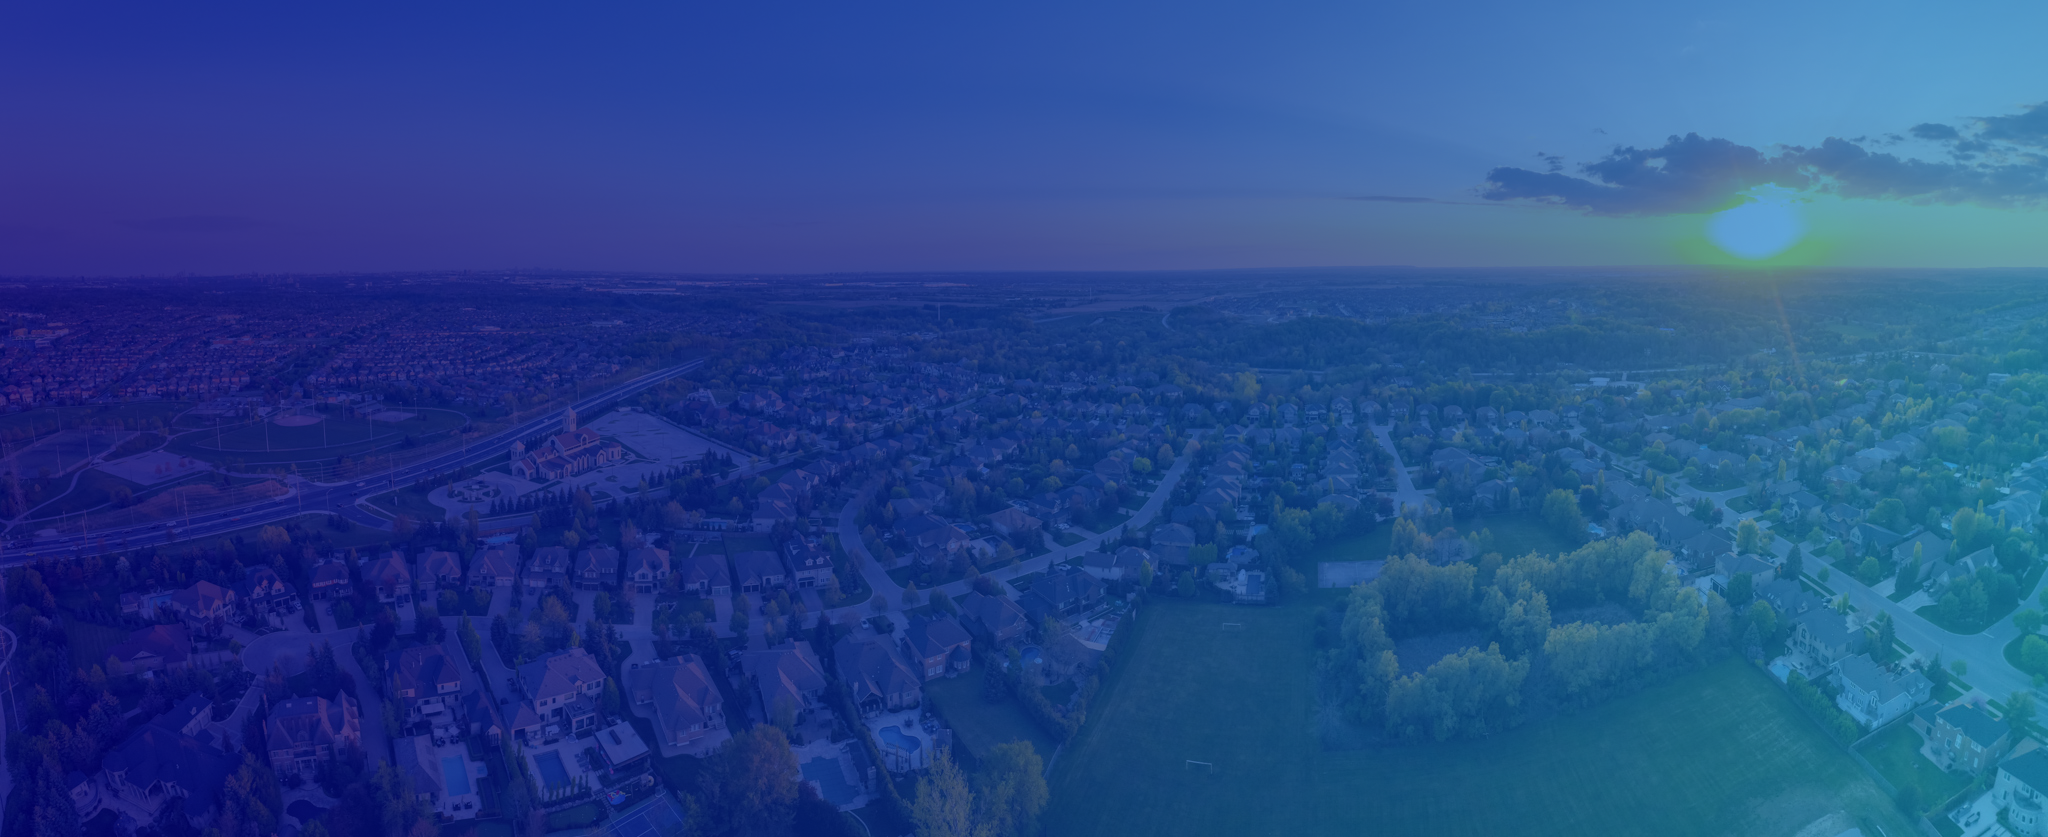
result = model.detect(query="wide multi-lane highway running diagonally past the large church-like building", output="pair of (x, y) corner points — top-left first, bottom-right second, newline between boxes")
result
(0, 360), (702, 565)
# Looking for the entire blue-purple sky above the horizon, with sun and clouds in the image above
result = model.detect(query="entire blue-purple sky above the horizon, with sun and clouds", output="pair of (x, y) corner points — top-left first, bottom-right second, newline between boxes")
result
(0, 0), (2048, 276)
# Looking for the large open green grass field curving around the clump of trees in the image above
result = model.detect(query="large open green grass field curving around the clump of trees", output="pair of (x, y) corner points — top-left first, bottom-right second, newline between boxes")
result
(1047, 598), (1913, 837)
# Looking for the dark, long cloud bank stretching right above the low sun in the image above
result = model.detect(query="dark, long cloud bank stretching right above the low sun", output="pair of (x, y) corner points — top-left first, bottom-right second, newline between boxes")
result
(1479, 106), (2048, 215)
